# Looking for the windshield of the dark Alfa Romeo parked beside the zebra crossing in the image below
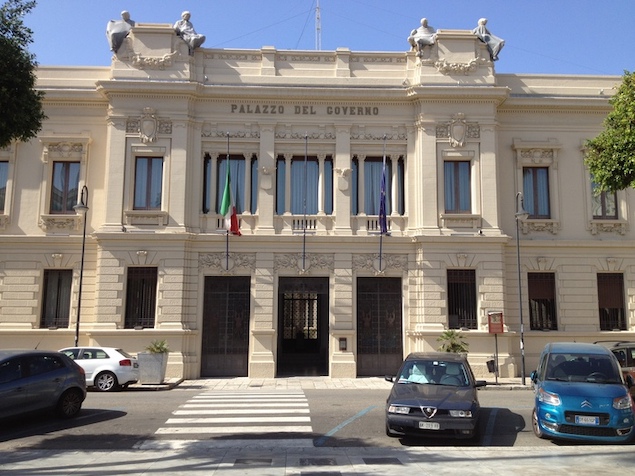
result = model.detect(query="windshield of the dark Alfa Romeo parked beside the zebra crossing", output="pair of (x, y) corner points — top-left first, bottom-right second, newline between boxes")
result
(398, 360), (469, 387)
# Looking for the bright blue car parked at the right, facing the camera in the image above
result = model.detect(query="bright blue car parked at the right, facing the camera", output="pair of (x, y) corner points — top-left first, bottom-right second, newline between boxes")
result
(531, 342), (635, 443)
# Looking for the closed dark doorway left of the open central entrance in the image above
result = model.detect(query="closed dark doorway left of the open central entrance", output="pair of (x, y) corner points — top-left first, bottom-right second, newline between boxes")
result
(201, 276), (251, 377)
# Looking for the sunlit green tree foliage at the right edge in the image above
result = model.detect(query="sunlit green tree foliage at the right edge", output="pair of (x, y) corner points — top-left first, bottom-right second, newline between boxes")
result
(585, 71), (635, 192)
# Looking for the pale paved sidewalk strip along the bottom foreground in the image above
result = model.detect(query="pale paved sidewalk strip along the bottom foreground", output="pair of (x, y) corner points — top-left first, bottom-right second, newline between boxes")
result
(0, 440), (635, 476)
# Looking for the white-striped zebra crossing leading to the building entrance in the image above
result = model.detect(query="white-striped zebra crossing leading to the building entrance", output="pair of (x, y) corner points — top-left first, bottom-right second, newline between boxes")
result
(138, 390), (313, 449)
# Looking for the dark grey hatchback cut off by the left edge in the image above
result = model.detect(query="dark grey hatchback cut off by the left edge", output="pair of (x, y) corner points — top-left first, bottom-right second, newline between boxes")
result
(0, 350), (86, 418)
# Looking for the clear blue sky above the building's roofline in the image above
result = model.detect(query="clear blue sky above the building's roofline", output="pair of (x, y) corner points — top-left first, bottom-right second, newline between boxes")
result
(25, 0), (635, 75)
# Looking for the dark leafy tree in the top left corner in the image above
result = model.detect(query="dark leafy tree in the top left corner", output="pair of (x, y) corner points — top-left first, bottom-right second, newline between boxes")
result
(0, 0), (46, 147)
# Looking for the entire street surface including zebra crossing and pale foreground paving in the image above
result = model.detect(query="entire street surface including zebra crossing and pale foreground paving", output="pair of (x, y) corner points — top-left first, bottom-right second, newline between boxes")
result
(0, 383), (635, 475)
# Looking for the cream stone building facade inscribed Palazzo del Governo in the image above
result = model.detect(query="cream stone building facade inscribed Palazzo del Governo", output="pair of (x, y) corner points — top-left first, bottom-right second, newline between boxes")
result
(0, 23), (635, 378)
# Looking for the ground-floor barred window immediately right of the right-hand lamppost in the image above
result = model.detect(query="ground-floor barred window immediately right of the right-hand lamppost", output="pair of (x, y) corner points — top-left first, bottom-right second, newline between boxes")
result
(527, 273), (558, 331)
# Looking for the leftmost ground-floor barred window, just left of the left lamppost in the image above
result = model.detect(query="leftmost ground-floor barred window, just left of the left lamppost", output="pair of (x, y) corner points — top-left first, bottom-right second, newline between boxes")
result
(40, 269), (73, 329)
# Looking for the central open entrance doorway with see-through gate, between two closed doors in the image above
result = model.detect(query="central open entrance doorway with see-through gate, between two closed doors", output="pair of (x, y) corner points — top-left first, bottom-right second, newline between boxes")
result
(276, 277), (329, 377)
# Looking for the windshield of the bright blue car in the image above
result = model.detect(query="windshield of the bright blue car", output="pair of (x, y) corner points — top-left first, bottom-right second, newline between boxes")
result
(546, 353), (622, 383)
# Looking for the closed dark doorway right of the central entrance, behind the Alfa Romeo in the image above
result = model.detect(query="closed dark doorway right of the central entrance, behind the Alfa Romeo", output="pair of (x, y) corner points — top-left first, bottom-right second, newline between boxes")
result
(357, 278), (403, 377)
